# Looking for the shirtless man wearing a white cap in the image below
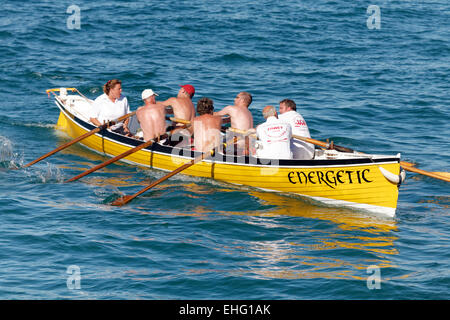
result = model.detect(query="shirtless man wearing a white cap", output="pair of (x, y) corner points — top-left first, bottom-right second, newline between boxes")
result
(136, 89), (166, 141)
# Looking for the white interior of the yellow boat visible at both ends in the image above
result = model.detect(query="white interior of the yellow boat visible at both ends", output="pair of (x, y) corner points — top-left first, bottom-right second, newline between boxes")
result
(57, 95), (400, 160)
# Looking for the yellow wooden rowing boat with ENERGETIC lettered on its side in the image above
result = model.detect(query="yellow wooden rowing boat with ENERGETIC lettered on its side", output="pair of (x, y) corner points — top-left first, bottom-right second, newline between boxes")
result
(51, 90), (404, 217)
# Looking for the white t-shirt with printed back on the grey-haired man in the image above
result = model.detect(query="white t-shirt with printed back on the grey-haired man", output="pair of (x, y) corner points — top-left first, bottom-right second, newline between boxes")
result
(256, 117), (292, 159)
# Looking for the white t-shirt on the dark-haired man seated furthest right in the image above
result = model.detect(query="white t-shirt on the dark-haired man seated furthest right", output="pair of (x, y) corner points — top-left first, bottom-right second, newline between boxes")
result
(278, 110), (314, 160)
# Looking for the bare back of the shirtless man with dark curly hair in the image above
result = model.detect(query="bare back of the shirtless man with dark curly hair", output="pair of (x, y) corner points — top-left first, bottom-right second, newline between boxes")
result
(193, 114), (222, 152)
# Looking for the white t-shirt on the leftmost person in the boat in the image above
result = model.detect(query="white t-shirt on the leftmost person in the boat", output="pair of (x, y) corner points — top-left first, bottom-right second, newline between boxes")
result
(91, 93), (130, 130)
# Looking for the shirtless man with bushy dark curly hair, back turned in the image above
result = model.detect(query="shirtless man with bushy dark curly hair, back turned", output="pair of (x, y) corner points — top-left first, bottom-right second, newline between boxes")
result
(191, 98), (222, 152)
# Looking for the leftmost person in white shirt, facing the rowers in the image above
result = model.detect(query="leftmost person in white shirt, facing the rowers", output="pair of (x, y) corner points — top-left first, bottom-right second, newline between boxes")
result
(90, 79), (130, 134)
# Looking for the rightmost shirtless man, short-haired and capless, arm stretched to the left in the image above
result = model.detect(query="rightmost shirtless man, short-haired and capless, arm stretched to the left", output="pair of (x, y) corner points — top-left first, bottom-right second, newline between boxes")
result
(214, 91), (253, 155)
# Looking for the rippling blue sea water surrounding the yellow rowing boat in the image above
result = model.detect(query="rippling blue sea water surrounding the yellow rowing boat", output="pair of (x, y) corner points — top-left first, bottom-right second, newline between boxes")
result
(0, 0), (450, 300)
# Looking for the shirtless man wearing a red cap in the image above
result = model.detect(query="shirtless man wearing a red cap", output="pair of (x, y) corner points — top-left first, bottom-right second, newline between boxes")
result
(161, 84), (195, 126)
